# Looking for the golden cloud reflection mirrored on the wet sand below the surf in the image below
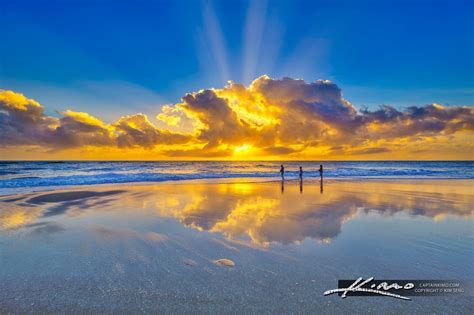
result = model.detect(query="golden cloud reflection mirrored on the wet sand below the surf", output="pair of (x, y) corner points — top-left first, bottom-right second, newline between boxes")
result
(0, 180), (474, 246)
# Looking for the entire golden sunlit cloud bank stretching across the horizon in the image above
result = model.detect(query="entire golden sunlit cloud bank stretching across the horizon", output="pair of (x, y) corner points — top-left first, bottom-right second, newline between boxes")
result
(0, 76), (474, 158)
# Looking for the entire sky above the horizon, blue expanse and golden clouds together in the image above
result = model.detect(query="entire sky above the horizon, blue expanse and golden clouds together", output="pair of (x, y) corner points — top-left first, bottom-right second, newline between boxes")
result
(0, 0), (474, 159)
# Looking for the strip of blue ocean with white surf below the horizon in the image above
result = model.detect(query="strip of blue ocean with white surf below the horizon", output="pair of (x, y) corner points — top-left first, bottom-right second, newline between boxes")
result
(0, 161), (474, 195)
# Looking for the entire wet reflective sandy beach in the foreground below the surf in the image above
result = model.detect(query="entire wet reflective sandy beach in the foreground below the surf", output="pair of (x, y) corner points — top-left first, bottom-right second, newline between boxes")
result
(0, 180), (474, 314)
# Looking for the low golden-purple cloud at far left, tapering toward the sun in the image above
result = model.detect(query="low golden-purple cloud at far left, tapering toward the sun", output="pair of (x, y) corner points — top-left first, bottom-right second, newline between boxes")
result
(0, 91), (190, 149)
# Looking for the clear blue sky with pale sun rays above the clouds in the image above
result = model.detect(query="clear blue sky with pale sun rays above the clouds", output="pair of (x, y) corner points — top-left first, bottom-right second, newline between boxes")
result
(0, 0), (474, 121)
